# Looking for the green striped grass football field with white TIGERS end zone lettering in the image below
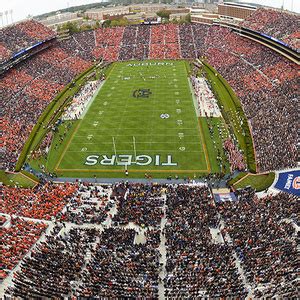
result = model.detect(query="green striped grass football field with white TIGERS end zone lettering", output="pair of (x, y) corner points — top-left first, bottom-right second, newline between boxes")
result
(54, 60), (210, 177)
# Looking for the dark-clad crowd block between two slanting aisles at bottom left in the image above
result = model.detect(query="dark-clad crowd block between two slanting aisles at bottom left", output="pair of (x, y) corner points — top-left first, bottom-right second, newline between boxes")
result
(7, 226), (96, 298)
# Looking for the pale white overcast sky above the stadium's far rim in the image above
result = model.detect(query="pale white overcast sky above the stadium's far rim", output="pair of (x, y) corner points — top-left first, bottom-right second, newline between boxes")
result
(0, 0), (300, 26)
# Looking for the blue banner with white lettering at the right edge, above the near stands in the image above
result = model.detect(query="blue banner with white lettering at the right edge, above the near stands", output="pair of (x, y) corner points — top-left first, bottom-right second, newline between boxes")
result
(274, 170), (300, 196)
